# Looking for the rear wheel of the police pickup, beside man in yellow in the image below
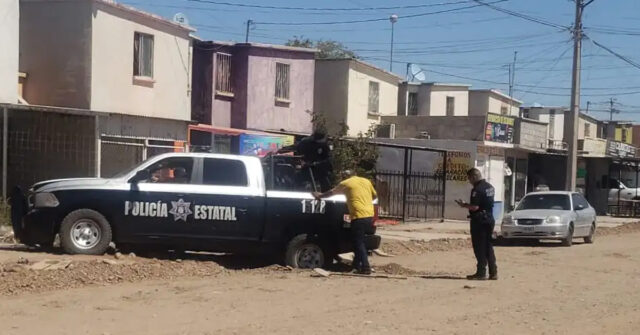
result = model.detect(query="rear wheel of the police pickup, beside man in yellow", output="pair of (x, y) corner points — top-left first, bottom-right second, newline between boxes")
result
(285, 234), (327, 269)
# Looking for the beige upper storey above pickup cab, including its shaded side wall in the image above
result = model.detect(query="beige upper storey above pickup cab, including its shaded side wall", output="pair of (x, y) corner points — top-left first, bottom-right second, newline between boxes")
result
(20, 0), (194, 121)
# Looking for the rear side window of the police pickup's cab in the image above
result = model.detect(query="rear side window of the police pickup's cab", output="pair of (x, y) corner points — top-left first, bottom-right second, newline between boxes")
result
(202, 158), (249, 186)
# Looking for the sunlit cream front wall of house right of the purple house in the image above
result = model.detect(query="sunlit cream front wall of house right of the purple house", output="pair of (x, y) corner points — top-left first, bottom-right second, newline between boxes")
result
(347, 61), (399, 136)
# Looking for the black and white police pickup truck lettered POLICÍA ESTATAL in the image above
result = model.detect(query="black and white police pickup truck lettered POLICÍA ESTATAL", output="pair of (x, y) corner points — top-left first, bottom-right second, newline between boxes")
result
(14, 153), (380, 268)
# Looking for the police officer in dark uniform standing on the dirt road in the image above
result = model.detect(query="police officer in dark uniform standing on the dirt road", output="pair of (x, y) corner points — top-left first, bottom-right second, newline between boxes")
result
(456, 168), (498, 280)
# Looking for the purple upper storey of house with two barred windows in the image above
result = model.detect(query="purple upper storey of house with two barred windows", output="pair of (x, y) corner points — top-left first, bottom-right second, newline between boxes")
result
(191, 41), (316, 133)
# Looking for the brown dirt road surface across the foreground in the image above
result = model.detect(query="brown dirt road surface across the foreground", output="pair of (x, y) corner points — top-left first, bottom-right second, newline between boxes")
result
(0, 224), (640, 334)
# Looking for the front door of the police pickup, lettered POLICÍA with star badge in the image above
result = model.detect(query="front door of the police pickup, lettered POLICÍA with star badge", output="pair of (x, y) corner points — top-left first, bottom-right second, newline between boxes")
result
(119, 156), (194, 242)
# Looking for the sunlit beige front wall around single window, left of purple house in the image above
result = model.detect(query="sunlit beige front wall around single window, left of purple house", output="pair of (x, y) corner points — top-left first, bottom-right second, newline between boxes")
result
(90, 2), (191, 120)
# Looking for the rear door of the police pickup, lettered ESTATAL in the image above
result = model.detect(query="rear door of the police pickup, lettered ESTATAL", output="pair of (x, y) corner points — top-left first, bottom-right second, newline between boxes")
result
(185, 157), (264, 242)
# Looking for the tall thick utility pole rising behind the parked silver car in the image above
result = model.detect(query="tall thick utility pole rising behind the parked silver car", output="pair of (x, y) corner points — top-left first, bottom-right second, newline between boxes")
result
(564, 0), (592, 191)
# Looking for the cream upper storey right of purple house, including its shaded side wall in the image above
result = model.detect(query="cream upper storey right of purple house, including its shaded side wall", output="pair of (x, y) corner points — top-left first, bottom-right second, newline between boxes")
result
(313, 59), (402, 136)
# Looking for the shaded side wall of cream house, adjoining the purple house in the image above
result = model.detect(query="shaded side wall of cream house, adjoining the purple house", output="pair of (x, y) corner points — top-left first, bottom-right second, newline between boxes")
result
(313, 60), (349, 132)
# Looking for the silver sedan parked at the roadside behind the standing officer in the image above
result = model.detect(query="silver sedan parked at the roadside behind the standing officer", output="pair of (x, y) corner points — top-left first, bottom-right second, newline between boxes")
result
(501, 191), (596, 246)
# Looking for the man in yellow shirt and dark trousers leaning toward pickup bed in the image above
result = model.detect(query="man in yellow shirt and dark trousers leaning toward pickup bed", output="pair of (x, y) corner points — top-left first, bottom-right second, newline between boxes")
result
(313, 170), (378, 274)
